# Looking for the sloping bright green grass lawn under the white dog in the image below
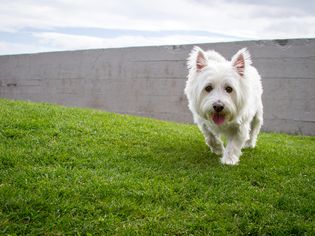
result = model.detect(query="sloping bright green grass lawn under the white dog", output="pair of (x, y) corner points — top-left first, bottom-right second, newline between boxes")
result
(0, 99), (315, 235)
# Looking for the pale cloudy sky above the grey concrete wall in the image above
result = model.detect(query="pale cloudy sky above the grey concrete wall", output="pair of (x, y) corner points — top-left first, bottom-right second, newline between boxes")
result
(0, 0), (315, 55)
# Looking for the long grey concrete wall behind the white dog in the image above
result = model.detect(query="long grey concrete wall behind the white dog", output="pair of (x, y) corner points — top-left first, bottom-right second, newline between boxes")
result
(0, 39), (315, 135)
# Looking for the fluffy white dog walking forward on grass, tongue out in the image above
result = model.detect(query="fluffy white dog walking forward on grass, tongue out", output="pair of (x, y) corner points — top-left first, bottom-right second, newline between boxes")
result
(185, 47), (263, 165)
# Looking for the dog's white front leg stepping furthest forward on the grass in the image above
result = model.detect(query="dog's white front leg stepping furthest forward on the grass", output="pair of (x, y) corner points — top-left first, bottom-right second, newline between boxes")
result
(221, 125), (249, 165)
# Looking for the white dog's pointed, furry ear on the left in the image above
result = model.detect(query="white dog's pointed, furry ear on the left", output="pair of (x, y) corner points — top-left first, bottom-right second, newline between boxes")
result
(187, 46), (208, 72)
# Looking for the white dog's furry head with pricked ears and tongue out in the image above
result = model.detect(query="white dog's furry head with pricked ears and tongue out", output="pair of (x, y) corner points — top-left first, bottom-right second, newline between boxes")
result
(185, 47), (251, 125)
